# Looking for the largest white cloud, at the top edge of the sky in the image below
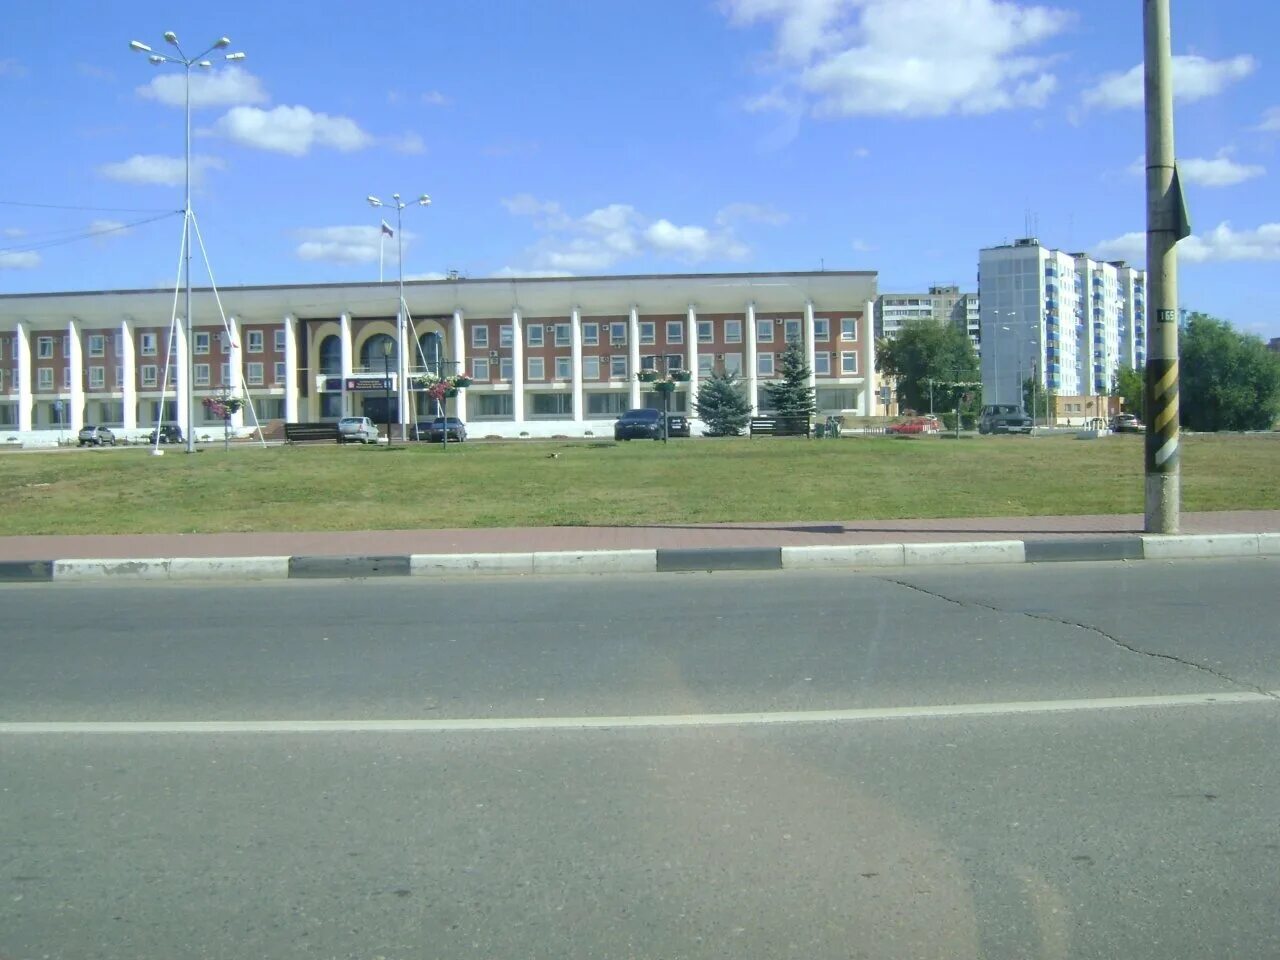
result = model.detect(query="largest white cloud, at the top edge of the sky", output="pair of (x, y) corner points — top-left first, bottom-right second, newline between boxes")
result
(722, 0), (1073, 116)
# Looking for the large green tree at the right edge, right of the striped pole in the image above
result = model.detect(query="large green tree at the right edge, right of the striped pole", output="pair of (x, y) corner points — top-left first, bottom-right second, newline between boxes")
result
(1179, 314), (1280, 430)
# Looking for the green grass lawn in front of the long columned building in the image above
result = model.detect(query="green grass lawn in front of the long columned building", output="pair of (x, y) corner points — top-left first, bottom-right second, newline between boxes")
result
(0, 436), (1280, 535)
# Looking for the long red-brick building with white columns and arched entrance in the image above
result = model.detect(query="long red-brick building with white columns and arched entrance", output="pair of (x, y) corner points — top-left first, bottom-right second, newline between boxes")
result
(0, 271), (877, 444)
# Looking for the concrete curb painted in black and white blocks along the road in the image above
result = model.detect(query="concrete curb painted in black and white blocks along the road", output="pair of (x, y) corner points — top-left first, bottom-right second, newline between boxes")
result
(0, 534), (1280, 582)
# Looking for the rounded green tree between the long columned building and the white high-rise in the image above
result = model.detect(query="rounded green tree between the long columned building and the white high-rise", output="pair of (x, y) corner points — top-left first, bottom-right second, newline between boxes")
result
(876, 320), (982, 410)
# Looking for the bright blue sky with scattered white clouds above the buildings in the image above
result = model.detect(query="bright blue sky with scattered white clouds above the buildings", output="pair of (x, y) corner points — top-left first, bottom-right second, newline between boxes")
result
(0, 0), (1280, 337)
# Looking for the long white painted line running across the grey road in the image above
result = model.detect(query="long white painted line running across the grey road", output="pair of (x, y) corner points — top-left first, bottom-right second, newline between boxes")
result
(0, 691), (1280, 736)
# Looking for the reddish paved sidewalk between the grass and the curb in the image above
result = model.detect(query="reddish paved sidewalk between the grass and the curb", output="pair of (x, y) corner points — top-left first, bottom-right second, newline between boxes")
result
(0, 511), (1280, 563)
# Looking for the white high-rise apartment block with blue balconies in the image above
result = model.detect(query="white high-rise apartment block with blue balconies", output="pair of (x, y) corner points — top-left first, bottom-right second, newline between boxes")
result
(978, 238), (1147, 403)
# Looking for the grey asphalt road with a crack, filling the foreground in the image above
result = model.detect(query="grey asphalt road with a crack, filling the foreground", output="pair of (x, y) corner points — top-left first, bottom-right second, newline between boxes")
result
(0, 561), (1280, 960)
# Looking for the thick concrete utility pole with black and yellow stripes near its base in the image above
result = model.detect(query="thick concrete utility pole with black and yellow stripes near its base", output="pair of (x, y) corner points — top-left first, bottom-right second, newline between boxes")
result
(1142, 0), (1190, 534)
